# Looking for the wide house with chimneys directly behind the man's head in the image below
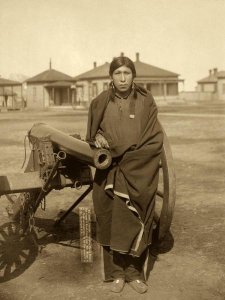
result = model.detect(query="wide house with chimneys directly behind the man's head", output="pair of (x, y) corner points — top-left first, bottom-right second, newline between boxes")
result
(74, 53), (183, 106)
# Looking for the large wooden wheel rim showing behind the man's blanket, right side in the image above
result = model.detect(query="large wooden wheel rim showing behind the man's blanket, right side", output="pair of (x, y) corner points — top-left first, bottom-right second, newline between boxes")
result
(154, 132), (176, 240)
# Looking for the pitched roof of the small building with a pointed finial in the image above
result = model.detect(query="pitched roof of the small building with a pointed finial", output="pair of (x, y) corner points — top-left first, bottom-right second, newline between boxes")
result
(26, 69), (73, 83)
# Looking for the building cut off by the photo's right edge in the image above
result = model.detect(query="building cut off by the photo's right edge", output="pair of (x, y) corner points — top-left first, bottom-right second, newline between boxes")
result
(197, 68), (225, 100)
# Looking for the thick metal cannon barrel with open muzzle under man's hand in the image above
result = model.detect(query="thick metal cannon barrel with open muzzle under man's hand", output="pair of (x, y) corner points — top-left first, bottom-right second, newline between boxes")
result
(28, 123), (112, 169)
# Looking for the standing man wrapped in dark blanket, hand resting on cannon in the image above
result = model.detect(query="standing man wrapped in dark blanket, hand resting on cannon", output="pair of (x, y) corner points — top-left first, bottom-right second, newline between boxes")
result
(87, 56), (163, 293)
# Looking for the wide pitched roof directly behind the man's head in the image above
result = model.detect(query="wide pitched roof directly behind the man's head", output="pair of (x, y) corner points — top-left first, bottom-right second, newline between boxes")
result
(74, 60), (179, 81)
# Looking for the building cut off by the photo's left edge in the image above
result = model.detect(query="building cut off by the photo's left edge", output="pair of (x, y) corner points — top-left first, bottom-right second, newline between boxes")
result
(0, 77), (23, 110)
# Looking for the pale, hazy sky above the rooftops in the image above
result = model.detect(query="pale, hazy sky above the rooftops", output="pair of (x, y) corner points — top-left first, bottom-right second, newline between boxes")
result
(0, 0), (225, 91)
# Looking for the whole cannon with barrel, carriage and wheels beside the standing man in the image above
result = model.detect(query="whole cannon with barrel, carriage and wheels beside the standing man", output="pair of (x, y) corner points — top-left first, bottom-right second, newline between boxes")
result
(0, 123), (176, 282)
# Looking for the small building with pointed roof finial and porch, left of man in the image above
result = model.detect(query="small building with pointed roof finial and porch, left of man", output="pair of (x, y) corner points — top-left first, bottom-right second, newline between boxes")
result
(24, 62), (75, 109)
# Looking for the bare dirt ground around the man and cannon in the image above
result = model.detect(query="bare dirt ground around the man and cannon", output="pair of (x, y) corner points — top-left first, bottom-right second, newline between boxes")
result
(0, 103), (225, 300)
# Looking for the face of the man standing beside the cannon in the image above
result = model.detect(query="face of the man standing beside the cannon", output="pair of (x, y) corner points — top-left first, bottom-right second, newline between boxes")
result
(112, 66), (133, 93)
